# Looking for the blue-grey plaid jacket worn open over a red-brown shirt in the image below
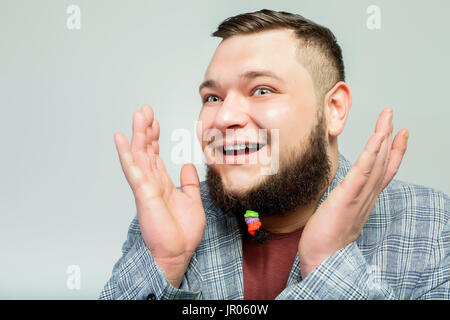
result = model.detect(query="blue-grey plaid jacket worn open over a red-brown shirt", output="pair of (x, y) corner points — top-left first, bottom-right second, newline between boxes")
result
(100, 153), (450, 299)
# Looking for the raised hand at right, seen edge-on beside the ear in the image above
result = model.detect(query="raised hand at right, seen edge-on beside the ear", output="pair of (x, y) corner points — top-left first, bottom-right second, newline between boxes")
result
(298, 108), (408, 278)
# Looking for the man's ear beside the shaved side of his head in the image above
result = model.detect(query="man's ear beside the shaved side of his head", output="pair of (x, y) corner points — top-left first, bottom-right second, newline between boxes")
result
(324, 81), (352, 137)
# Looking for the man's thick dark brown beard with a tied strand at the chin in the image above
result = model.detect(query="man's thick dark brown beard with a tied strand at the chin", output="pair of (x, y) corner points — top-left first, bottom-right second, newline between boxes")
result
(206, 112), (331, 243)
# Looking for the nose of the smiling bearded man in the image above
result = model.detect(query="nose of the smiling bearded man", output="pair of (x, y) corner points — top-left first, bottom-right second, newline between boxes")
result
(214, 92), (249, 132)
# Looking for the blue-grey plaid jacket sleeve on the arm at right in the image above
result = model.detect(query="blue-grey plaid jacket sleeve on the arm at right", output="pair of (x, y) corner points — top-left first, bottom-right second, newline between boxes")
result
(277, 187), (450, 300)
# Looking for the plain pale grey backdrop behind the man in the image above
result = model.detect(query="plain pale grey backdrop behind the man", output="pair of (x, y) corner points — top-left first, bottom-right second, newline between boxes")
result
(0, 0), (450, 299)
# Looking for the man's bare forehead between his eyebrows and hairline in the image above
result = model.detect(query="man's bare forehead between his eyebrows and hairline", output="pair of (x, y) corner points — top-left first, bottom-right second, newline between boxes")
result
(205, 30), (306, 81)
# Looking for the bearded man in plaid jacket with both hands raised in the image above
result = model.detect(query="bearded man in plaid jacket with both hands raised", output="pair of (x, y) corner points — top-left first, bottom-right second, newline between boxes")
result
(100, 10), (450, 299)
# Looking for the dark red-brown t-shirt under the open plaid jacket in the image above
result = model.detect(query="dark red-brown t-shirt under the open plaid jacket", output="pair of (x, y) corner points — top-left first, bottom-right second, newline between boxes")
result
(242, 228), (303, 300)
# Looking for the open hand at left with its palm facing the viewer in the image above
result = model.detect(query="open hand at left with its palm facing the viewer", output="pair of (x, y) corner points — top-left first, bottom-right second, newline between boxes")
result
(114, 106), (206, 288)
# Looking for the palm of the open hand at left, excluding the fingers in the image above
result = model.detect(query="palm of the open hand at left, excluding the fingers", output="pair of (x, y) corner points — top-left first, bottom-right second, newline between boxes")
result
(135, 167), (205, 259)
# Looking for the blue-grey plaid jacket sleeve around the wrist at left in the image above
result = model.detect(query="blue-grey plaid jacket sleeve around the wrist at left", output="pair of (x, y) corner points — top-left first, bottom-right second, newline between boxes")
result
(99, 216), (201, 300)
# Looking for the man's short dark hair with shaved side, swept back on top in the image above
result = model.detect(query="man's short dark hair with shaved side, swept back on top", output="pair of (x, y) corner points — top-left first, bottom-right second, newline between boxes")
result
(212, 9), (345, 99)
